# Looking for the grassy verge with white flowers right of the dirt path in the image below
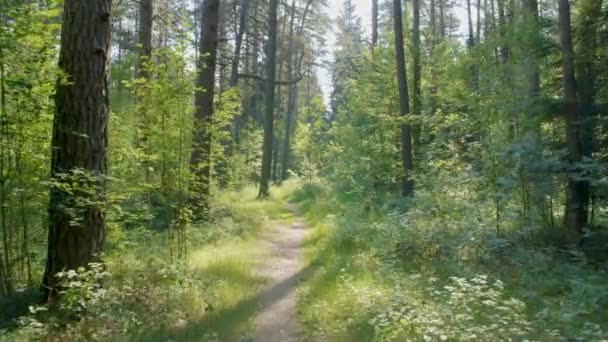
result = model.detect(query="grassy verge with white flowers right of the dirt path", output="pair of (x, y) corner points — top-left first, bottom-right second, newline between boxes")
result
(293, 180), (608, 341)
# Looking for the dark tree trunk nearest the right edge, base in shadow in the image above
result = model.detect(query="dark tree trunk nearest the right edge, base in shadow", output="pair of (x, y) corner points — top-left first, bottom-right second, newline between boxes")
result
(559, 0), (589, 237)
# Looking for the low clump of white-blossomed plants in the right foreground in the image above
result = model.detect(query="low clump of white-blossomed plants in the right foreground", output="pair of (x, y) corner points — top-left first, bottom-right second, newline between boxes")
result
(370, 275), (531, 341)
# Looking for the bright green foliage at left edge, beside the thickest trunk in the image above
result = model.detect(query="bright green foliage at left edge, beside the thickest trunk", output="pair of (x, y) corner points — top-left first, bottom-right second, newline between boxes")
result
(0, 0), (60, 297)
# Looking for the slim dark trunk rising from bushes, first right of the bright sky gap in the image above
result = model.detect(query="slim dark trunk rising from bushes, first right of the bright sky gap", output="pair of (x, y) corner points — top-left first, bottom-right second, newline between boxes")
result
(393, 0), (414, 196)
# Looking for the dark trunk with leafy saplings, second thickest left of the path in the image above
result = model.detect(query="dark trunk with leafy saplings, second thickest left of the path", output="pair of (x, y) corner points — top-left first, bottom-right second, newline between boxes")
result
(190, 0), (220, 219)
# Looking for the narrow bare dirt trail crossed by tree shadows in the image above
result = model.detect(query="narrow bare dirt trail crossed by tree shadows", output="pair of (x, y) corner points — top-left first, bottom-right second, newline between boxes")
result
(254, 206), (307, 342)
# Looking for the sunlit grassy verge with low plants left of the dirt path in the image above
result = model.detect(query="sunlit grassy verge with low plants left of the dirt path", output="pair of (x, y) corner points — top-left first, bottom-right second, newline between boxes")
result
(0, 183), (298, 341)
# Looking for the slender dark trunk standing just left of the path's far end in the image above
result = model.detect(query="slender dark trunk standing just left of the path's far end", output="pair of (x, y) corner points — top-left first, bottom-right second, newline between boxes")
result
(258, 0), (278, 197)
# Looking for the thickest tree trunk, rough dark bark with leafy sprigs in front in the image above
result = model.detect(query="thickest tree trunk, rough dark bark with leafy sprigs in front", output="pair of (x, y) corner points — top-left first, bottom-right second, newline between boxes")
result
(43, 0), (112, 301)
